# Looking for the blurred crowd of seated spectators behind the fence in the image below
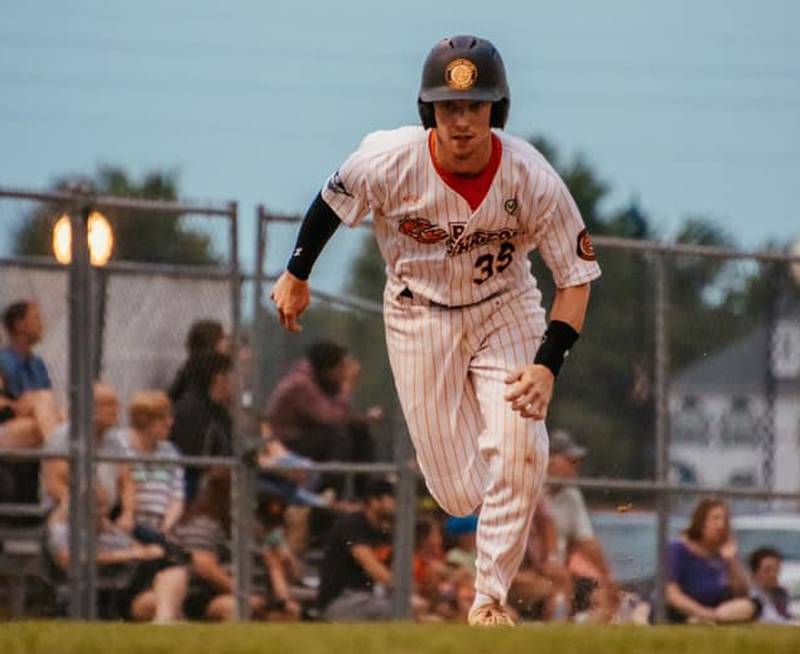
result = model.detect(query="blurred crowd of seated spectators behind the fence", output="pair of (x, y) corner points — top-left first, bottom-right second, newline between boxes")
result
(0, 299), (797, 624)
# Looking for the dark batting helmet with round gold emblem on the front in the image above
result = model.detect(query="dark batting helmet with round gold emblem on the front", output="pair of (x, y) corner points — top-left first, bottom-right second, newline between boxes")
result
(417, 36), (511, 129)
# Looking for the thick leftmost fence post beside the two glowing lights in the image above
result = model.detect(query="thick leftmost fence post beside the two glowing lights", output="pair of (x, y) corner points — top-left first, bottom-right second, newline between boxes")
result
(68, 195), (96, 619)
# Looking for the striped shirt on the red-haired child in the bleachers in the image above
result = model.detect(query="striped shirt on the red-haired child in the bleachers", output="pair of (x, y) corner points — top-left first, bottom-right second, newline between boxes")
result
(115, 430), (184, 531)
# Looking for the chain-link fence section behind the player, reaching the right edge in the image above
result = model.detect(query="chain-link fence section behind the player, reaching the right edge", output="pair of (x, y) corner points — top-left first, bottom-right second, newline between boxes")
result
(256, 207), (800, 620)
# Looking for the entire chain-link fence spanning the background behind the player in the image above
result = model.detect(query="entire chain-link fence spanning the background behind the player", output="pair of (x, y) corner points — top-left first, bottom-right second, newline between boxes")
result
(0, 191), (800, 619)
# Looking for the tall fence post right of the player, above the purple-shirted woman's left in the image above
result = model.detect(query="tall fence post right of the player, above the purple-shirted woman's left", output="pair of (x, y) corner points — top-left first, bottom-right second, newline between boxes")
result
(653, 252), (671, 623)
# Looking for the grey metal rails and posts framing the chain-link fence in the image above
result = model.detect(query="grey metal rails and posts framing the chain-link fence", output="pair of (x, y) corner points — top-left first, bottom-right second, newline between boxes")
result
(0, 187), (800, 619)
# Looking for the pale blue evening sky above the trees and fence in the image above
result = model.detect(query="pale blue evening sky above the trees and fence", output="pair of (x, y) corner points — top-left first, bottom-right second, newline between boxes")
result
(0, 0), (800, 290)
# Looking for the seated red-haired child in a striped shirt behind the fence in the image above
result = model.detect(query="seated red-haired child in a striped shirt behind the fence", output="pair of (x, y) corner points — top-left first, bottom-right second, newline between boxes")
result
(117, 391), (185, 543)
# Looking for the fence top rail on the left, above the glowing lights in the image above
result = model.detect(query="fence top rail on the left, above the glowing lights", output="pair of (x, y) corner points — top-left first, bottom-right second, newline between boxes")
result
(0, 186), (236, 217)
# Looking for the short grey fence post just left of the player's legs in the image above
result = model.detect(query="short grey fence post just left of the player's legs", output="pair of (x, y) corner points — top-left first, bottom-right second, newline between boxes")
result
(392, 428), (417, 620)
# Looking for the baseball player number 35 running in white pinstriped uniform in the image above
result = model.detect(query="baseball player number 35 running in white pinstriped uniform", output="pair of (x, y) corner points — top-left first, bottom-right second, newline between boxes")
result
(272, 36), (600, 626)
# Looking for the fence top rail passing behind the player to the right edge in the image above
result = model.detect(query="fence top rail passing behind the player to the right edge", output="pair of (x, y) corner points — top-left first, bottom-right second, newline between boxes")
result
(259, 206), (800, 263)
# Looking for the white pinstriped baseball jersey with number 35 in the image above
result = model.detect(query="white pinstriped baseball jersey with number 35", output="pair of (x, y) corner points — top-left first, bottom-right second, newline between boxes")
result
(322, 127), (600, 318)
